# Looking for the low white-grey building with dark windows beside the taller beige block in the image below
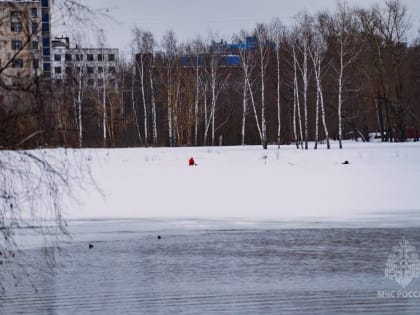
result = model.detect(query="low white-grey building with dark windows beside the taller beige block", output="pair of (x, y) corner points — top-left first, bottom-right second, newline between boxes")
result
(51, 37), (119, 87)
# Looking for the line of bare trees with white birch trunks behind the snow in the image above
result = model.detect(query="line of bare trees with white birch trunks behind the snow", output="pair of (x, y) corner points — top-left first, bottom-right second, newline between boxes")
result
(0, 0), (420, 149)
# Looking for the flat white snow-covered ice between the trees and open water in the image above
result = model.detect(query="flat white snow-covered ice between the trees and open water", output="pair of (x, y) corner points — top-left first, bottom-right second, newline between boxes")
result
(66, 142), (420, 220)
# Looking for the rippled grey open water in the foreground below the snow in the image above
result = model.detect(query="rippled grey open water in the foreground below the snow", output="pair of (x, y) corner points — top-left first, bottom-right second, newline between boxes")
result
(0, 220), (420, 315)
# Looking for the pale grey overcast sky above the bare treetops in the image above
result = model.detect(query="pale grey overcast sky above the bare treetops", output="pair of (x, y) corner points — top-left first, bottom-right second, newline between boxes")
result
(57, 0), (420, 52)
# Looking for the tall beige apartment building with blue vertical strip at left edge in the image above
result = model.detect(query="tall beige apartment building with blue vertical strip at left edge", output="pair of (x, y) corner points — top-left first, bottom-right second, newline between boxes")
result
(0, 0), (51, 85)
